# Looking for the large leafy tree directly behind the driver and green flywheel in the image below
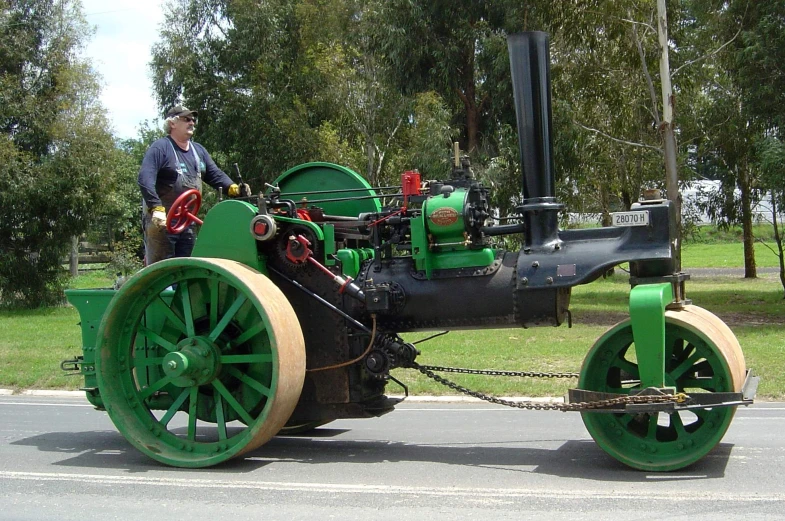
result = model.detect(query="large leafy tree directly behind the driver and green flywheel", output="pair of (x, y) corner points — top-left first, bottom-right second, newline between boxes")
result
(152, 0), (451, 186)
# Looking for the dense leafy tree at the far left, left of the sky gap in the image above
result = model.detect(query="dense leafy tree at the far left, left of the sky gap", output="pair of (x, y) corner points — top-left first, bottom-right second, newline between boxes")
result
(0, 0), (113, 307)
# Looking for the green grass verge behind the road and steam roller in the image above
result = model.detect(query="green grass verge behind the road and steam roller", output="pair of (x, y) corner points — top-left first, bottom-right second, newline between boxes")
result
(0, 268), (785, 400)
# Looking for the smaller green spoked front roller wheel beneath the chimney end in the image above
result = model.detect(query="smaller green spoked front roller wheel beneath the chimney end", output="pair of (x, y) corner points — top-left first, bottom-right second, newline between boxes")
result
(579, 306), (746, 471)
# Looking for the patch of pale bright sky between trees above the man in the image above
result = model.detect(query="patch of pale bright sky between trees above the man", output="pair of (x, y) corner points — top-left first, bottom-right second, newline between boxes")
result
(82, 0), (164, 138)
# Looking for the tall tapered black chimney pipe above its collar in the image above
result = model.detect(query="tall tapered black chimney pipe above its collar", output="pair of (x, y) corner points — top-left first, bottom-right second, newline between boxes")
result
(507, 31), (555, 201)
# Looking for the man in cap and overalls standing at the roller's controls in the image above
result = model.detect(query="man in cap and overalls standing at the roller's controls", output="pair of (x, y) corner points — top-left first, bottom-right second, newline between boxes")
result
(138, 105), (250, 265)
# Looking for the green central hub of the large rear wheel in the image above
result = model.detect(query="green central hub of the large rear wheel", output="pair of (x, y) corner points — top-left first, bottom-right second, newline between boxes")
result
(162, 337), (221, 387)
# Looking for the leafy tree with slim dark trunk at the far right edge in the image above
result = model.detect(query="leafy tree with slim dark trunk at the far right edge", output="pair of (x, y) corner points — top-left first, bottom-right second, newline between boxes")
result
(690, 0), (785, 278)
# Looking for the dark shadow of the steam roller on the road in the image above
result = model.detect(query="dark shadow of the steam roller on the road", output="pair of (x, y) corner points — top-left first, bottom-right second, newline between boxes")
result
(12, 428), (733, 482)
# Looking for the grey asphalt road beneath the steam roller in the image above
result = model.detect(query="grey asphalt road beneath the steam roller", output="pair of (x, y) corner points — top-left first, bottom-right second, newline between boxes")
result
(0, 396), (785, 521)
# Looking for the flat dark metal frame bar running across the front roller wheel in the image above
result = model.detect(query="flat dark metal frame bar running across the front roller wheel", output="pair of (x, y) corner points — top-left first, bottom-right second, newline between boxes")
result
(567, 371), (760, 414)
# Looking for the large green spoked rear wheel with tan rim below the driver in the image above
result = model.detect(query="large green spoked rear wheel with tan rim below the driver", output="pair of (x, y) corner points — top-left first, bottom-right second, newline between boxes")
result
(96, 257), (305, 467)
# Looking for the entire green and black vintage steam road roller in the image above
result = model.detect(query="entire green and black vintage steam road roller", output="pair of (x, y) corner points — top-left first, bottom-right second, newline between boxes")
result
(65, 33), (757, 471)
